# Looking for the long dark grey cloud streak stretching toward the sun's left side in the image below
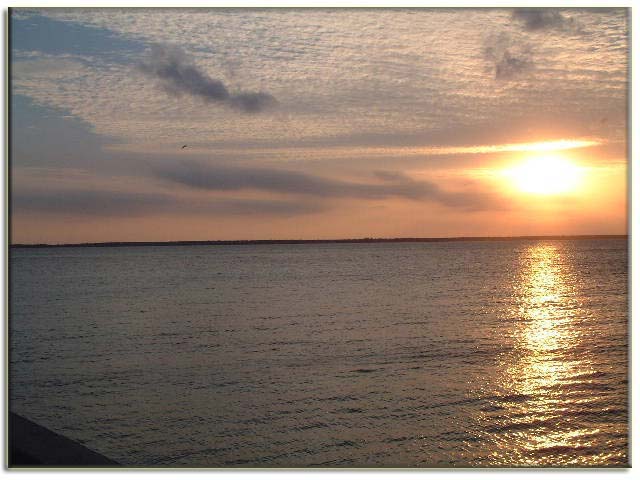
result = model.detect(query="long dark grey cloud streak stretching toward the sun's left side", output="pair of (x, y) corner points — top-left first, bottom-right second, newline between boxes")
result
(154, 162), (499, 210)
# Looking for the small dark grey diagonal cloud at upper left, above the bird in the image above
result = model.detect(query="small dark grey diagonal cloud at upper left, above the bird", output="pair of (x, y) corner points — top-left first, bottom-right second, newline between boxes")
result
(138, 45), (276, 113)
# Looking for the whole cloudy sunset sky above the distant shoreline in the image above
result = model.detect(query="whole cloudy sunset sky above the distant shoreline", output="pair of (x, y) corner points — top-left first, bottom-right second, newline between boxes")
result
(10, 8), (629, 243)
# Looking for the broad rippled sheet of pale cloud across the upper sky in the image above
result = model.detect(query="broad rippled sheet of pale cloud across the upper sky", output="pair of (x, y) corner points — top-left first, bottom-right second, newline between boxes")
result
(12, 9), (629, 155)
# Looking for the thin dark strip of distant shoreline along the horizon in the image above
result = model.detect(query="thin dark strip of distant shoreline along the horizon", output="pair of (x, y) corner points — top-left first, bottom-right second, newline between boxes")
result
(9, 234), (629, 248)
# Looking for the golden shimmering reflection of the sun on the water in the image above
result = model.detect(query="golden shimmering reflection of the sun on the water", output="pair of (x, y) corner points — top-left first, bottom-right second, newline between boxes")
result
(483, 244), (615, 466)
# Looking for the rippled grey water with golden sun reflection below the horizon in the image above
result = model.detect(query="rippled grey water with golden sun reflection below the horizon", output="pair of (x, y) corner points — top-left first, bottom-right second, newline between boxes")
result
(9, 240), (629, 467)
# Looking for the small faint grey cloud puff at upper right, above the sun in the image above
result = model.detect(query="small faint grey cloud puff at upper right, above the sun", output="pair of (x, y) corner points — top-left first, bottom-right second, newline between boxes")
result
(484, 33), (534, 80)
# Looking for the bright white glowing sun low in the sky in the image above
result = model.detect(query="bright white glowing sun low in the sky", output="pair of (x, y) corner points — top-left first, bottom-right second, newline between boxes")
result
(503, 154), (583, 195)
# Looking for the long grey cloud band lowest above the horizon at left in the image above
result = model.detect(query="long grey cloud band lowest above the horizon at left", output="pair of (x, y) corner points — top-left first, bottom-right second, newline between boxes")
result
(11, 190), (326, 217)
